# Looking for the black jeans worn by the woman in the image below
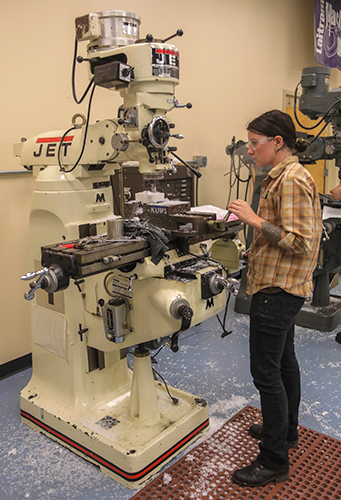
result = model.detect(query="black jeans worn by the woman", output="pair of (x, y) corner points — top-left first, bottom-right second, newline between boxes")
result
(250, 291), (305, 469)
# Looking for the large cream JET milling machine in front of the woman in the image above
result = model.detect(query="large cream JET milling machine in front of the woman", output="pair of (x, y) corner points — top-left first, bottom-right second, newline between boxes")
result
(15, 11), (243, 488)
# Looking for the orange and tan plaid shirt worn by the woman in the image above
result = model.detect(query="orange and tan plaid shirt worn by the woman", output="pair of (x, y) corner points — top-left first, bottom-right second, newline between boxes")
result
(247, 156), (322, 297)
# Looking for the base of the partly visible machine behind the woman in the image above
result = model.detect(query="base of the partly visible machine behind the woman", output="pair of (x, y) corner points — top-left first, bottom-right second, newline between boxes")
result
(296, 295), (341, 332)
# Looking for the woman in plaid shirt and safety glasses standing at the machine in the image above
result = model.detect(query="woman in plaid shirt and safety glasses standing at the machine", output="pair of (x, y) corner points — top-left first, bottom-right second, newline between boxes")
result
(228, 110), (322, 486)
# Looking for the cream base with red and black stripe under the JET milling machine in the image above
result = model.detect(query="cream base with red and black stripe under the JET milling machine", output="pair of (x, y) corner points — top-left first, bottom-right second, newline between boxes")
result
(20, 383), (209, 488)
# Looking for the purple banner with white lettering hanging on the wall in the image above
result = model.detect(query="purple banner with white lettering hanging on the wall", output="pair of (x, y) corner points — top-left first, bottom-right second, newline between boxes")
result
(315, 0), (341, 69)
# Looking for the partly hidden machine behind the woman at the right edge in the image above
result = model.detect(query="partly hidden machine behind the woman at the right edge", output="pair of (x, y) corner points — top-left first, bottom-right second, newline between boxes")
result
(294, 66), (341, 331)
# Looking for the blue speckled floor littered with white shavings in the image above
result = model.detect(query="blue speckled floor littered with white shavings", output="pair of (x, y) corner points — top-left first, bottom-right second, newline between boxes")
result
(0, 294), (341, 500)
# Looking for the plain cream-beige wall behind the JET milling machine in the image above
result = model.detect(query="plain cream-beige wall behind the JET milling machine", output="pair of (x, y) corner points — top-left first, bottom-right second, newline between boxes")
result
(0, 0), (341, 364)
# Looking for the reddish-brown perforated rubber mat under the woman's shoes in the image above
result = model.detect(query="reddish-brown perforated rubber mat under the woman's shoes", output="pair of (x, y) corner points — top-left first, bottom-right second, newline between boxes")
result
(131, 406), (341, 500)
